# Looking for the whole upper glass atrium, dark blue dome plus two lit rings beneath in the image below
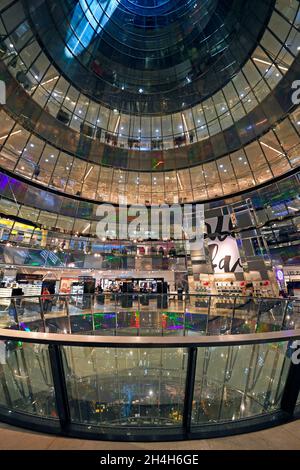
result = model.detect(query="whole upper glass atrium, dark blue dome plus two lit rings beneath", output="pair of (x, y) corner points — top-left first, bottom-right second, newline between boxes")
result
(0, 0), (300, 204)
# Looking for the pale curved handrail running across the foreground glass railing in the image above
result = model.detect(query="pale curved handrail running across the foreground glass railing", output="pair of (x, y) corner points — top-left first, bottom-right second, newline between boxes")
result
(0, 328), (300, 348)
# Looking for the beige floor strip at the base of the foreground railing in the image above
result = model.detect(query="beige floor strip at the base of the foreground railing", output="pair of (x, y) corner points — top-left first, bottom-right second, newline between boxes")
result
(0, 421), (300, 451)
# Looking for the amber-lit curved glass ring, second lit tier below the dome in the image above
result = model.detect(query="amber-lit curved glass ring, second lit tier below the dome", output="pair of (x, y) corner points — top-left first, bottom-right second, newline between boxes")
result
(0, 107), (300, 204)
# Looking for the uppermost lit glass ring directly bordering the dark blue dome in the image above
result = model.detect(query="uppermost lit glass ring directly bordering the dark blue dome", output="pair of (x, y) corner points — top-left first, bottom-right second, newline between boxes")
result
(1, 1), (299, 154)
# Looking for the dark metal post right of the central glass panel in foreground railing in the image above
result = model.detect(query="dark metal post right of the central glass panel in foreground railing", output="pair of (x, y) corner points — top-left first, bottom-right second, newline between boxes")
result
(182, 346), (197, 435)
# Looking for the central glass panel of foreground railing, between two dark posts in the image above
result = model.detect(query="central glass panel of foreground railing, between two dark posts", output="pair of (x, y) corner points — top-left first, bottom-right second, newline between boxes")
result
(63, 346), (187, 429)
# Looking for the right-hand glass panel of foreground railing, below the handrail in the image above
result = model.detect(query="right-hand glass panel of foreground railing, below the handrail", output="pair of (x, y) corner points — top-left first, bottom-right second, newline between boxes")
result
(192, 342), (290, 427)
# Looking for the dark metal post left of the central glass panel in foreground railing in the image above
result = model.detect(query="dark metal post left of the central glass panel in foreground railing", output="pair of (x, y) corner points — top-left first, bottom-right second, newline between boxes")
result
(49, 344), (71, 430)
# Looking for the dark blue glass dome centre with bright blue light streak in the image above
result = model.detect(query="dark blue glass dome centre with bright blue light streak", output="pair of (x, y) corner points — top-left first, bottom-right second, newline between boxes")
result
(25, 0), (274, 115)
